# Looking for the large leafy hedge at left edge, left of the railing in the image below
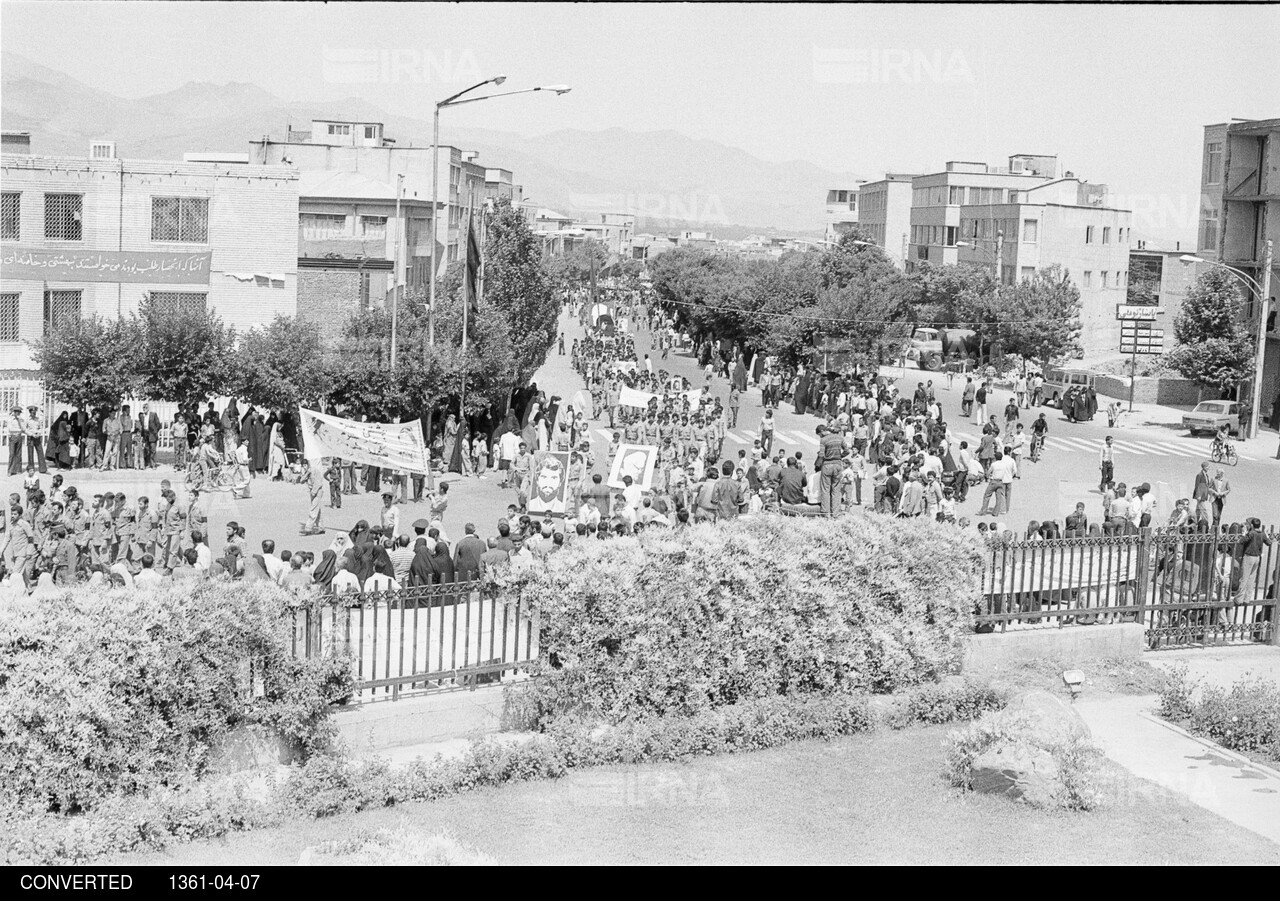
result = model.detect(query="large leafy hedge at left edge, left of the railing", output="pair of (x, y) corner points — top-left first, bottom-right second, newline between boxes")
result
(0, 582), (351, 814)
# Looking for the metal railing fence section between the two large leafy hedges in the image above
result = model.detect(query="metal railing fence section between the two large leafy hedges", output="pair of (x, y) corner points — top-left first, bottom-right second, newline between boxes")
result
(293, 581), (538, 701)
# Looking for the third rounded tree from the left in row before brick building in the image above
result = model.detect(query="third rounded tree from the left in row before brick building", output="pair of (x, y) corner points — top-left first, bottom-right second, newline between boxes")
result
(234, 316), (328, 410)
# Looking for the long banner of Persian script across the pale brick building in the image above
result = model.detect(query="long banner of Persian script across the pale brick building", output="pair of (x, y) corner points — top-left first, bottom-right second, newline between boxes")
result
(0, 247), (212, 284)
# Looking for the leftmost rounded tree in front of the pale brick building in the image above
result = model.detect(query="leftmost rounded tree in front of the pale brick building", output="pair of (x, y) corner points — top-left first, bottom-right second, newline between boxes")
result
(31, 316), (141, 408)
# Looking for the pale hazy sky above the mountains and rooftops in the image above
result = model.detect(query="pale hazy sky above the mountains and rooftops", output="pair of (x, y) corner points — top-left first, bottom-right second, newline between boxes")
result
(0, 0), (1280, 237)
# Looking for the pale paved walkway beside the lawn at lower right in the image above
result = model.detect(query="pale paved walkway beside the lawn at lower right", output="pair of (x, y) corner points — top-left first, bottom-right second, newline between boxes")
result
(1075, 646), (1280, 843)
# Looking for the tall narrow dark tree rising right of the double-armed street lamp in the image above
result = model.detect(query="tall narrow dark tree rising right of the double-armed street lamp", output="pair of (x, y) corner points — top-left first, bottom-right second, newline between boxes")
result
(484, 200), (561, 384)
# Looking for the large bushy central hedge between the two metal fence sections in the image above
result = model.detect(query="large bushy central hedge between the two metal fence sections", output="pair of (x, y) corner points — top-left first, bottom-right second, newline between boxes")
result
(494, 517), (982, 724)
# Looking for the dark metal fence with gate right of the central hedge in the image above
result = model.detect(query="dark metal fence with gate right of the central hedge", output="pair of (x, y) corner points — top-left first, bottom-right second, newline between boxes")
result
(977, 529), (1280, 648)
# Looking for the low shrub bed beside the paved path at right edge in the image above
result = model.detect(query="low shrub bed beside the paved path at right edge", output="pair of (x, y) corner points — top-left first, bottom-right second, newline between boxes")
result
(1160, 667), (1280, 761)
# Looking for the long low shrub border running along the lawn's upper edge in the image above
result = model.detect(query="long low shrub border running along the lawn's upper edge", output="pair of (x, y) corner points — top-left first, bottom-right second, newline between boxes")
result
(0, 683), (1004, 865)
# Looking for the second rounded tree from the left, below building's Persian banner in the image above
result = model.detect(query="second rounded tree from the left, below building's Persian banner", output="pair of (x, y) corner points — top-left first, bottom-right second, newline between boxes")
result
(132, 294), (237, 403)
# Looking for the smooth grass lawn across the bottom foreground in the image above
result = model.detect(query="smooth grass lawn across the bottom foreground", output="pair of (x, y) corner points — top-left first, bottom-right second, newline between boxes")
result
(112, 727), (1280, 866)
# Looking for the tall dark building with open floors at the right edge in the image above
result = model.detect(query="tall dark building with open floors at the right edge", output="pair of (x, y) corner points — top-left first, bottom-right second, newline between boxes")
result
(1197, 119), (1280, 415)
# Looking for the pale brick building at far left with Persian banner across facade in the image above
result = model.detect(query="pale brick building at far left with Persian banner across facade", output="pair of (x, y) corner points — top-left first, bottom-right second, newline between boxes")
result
(0, 147), (298, 378)
